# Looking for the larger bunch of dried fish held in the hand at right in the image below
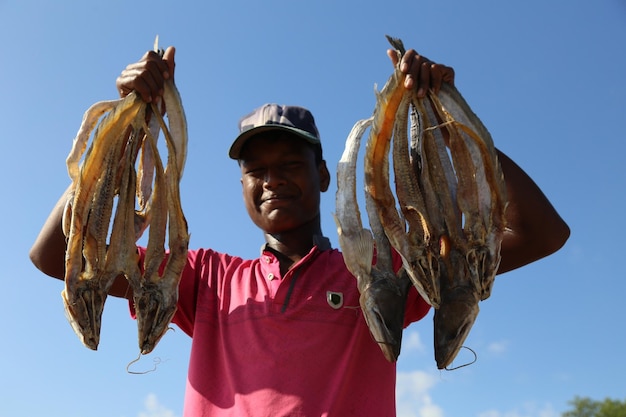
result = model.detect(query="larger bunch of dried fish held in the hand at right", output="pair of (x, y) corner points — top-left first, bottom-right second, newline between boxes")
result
(336, 38), (507, 369)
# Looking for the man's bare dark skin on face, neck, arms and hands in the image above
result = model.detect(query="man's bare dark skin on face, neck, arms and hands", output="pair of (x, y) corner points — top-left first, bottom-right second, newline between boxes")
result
(30, 47), (570, 298)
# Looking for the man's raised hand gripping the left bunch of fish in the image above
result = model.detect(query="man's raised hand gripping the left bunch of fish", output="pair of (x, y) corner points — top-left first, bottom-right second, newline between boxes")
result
(115, 46), (176, 103)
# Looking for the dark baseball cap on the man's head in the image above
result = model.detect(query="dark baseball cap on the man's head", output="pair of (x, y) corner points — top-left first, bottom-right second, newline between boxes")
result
(228, 103), (321, 159)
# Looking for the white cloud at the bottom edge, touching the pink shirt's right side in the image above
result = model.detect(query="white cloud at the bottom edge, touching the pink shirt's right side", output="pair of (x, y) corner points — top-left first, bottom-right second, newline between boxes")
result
(396, 371), (444, 417)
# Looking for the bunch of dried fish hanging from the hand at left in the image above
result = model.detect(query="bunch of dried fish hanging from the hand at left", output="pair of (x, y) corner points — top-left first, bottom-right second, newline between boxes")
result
(62, 41), (189, 354)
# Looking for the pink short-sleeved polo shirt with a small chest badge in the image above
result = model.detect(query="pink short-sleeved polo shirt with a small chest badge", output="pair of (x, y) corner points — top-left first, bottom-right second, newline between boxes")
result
(138, 240), (428, 417)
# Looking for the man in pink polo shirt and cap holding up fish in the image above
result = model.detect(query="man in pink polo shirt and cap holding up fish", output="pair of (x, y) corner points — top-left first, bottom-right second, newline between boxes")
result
(31, 44), (569, 417)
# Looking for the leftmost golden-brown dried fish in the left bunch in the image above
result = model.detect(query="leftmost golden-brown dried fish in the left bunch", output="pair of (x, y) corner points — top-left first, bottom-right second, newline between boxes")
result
(62, 94), (145, 349)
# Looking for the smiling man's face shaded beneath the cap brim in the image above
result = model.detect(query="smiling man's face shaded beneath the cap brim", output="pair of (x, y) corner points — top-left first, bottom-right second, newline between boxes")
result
(240, 131), (330, 234)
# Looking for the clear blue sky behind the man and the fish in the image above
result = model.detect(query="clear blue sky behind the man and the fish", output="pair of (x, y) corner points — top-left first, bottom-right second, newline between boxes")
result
(0, 0), (626, 417)
